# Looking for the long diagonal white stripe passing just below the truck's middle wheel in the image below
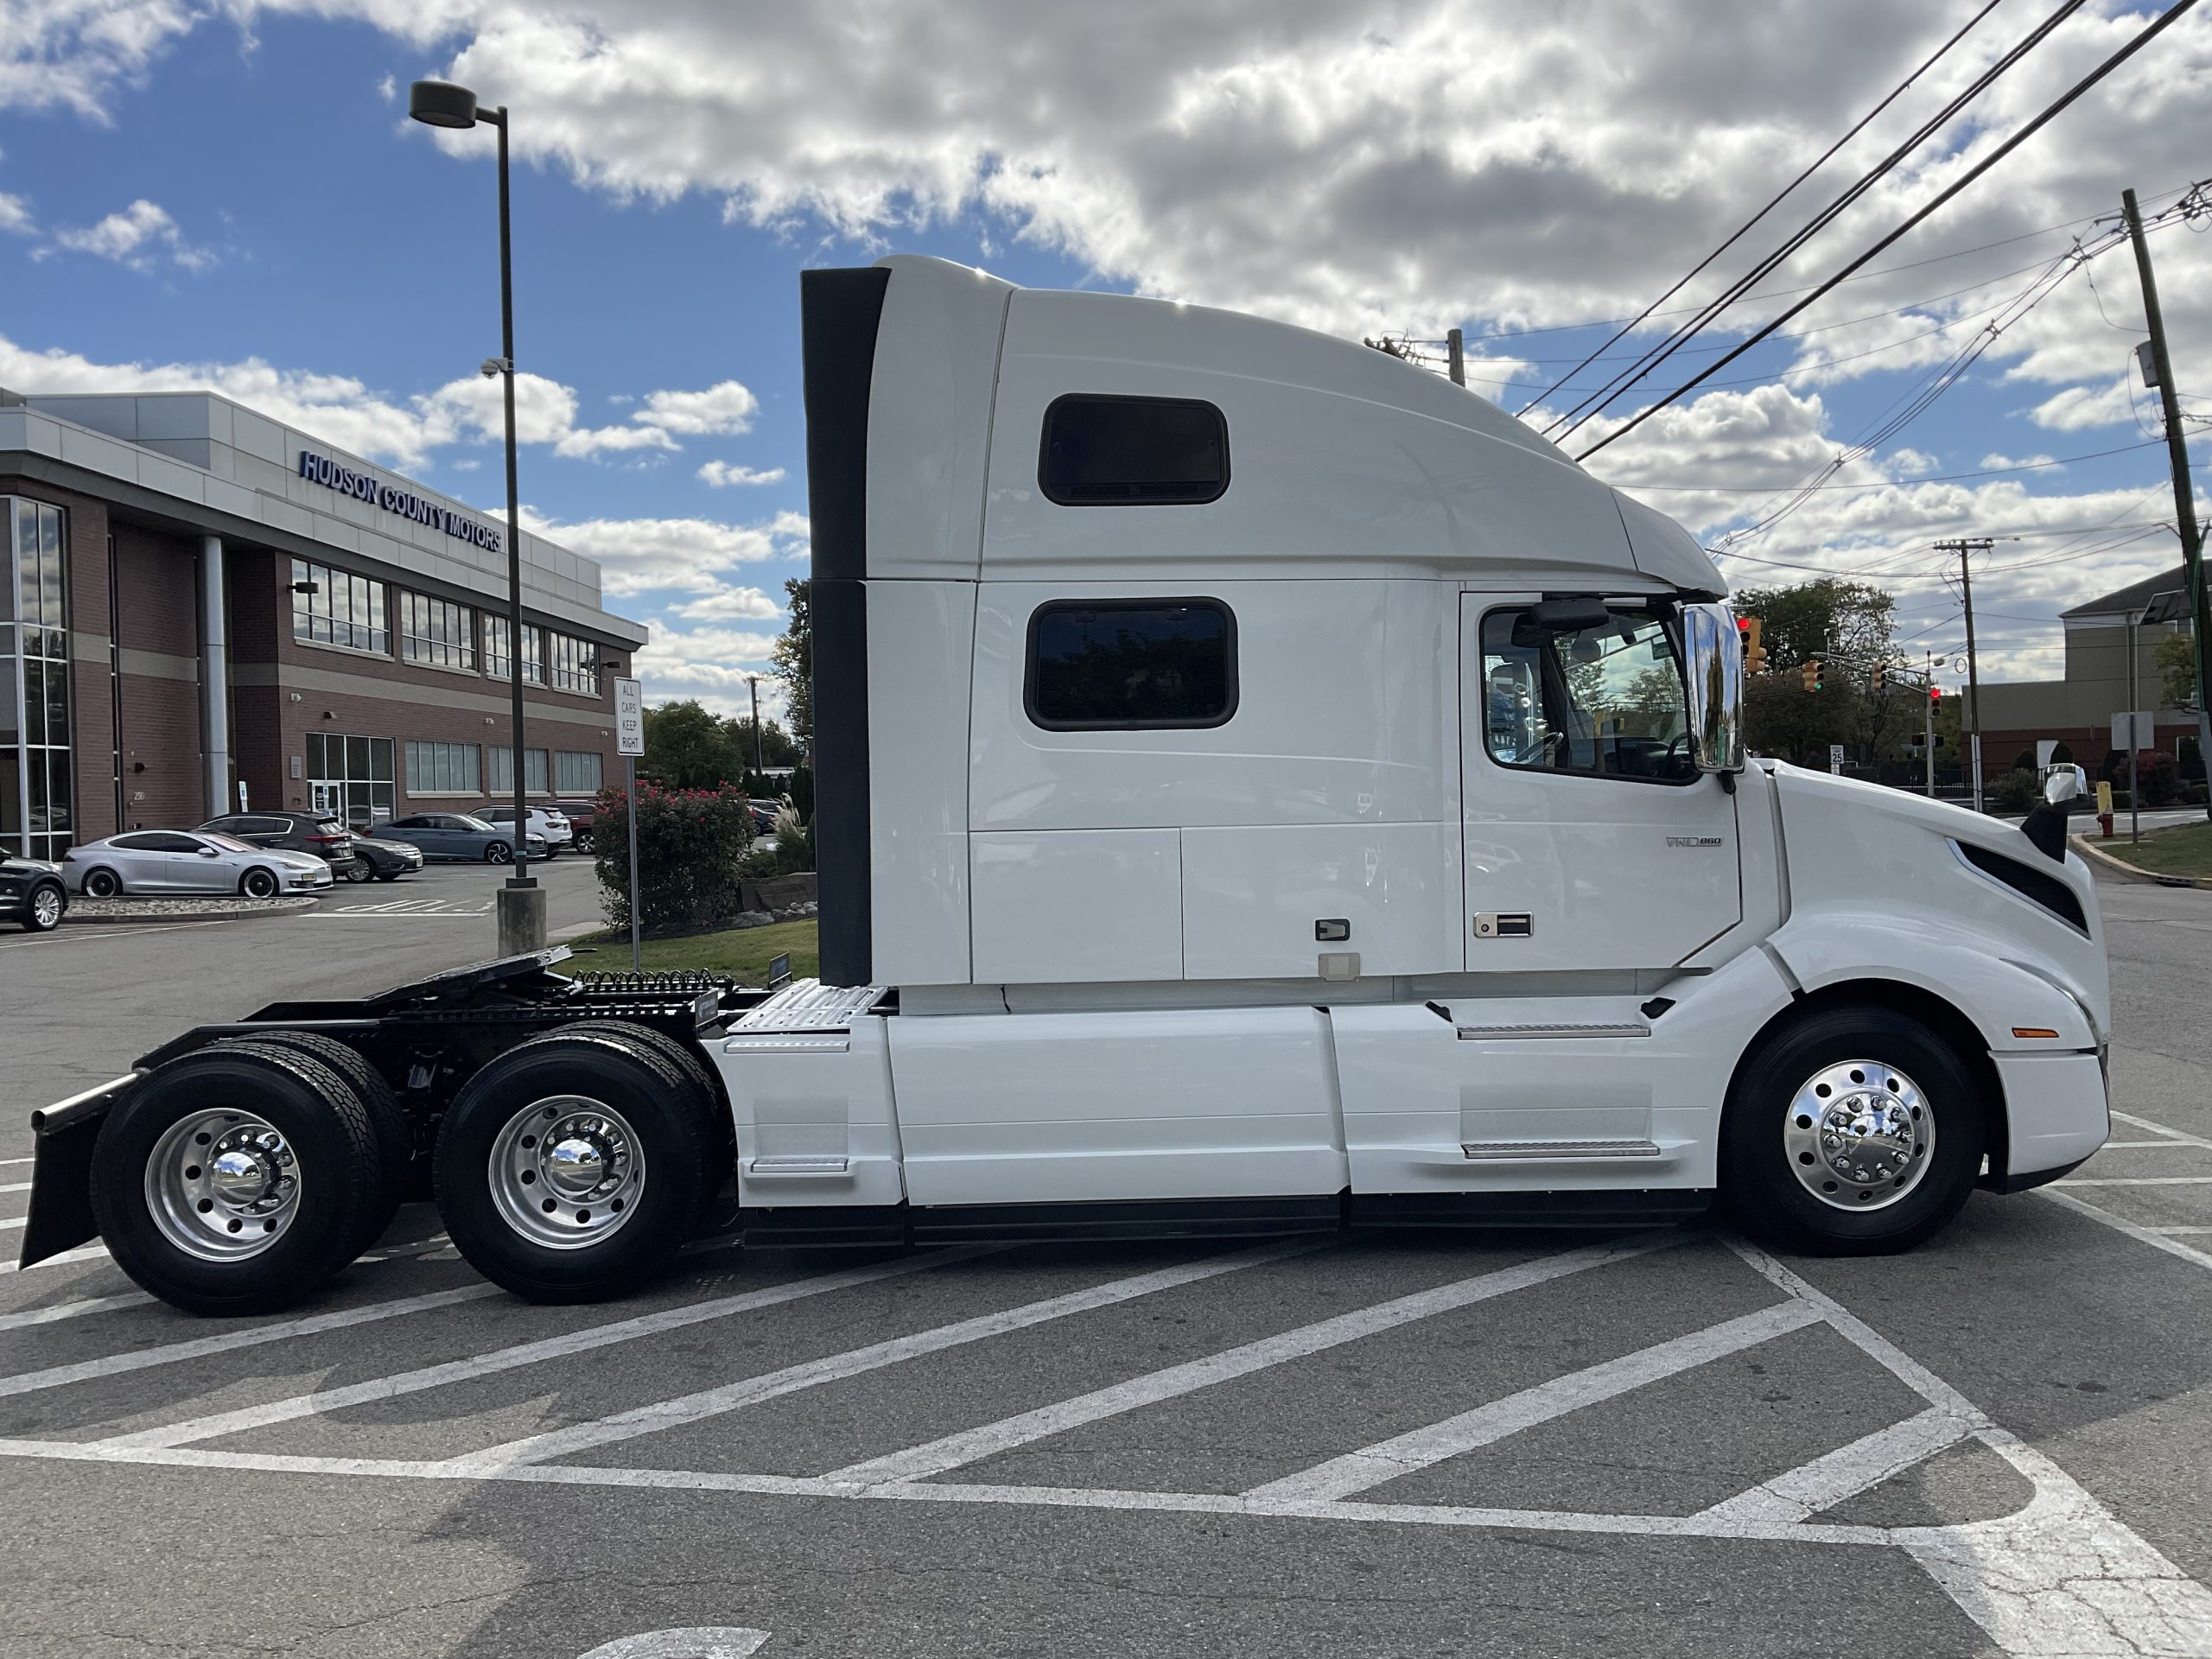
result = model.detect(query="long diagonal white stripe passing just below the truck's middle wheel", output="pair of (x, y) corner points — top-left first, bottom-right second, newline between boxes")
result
(99, 1245), (995, 1449)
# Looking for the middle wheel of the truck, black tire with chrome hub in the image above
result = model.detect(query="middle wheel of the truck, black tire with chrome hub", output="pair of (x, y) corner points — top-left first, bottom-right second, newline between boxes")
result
(434, 1027), (719, 1303)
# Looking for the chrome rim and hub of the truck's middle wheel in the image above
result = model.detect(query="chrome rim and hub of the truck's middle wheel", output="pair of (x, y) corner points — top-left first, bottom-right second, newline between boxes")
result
(489, 1095), (646, 1249)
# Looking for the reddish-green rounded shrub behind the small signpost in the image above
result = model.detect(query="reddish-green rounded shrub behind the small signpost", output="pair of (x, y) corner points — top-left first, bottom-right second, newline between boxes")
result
(591, 783), (752, 929)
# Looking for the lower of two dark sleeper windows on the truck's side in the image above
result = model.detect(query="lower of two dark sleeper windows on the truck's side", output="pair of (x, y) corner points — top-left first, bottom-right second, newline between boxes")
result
(1024, 600), (1236, 732)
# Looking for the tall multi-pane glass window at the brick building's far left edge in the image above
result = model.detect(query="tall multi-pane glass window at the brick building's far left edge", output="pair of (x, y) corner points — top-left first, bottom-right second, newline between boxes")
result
(0, 498), (75, 858)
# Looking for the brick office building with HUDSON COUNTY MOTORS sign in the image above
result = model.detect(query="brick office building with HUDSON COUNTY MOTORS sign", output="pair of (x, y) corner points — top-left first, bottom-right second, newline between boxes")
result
(0, 391), (646, 858)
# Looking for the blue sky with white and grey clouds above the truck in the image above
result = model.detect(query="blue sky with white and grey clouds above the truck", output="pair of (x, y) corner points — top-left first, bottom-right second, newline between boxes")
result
(0, 0), (2212, 708)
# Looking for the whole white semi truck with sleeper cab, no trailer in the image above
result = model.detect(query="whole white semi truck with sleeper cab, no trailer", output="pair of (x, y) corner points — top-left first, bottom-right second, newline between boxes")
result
(24, 257), (2108, 1312)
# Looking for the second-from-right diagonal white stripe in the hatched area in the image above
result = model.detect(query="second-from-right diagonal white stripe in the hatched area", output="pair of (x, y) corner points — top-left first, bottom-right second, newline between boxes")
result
(1245, 1299), (1821, 1504)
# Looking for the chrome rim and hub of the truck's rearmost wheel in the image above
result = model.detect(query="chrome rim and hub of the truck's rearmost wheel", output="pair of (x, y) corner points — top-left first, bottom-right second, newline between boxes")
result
(146, 1109), (301, 1261)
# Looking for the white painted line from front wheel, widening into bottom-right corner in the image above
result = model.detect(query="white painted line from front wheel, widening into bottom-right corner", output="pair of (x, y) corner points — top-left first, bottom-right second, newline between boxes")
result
(1730, 1238), (2212, 1659)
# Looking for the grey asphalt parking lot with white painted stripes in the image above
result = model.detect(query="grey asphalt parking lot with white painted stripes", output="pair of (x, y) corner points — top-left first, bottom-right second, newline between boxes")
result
(0, 862), (2212, 1659)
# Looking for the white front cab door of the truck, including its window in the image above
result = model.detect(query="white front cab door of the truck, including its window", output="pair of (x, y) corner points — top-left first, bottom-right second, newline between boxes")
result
(1460, 593), (1743, 973)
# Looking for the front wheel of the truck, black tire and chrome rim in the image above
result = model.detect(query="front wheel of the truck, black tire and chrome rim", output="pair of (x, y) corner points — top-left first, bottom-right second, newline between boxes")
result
(1721, 1007), (1984, 1256)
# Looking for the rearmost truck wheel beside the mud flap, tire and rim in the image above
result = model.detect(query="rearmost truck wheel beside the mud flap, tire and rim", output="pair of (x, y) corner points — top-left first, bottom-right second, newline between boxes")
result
(91, 1042), (376, 1314)
